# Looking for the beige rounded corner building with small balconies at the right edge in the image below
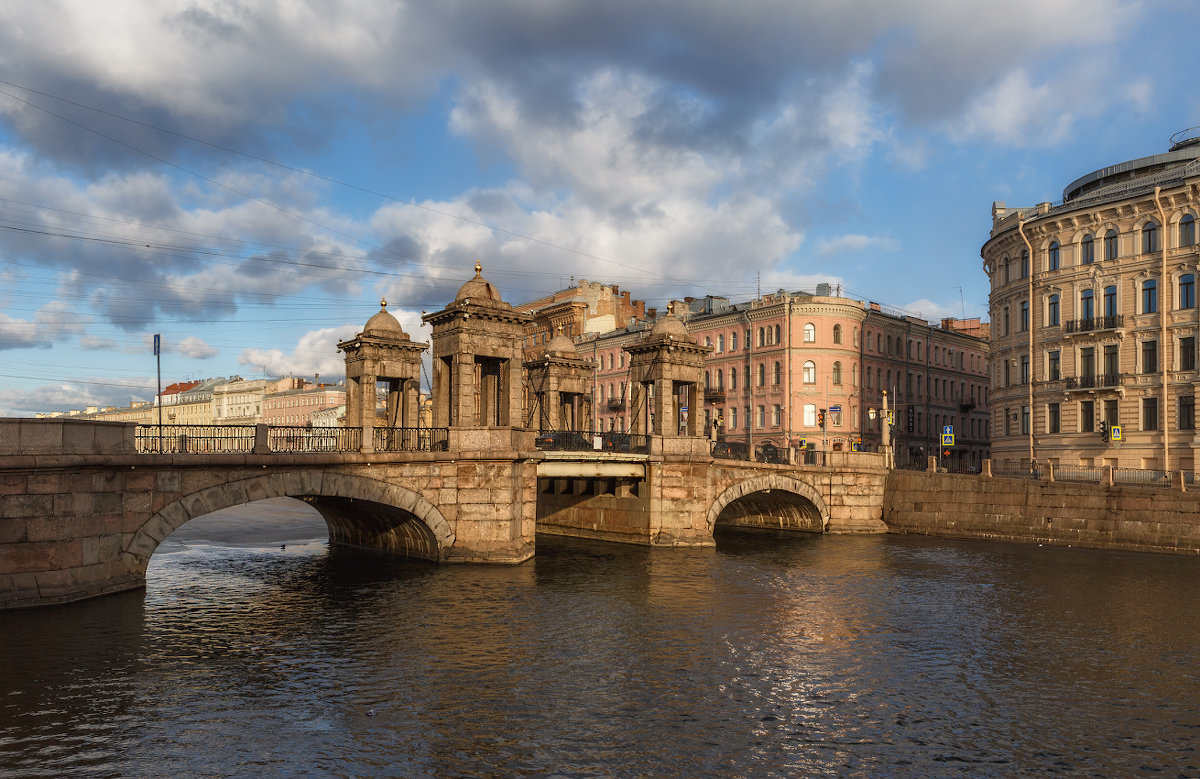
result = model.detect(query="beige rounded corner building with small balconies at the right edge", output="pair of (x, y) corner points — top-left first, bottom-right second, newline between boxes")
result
(980, 130), (1200, 472)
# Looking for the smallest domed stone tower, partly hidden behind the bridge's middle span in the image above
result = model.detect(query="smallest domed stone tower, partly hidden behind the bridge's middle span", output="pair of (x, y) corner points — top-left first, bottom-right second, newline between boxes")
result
(526, 325), (595, 431)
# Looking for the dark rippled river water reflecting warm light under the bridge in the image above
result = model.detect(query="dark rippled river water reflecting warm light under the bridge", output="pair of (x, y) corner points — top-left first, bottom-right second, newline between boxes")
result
(0, 499), (1200, 777)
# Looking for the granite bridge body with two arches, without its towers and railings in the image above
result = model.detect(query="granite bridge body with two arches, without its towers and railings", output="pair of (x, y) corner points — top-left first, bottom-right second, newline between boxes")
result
(0, 419), (887, 609)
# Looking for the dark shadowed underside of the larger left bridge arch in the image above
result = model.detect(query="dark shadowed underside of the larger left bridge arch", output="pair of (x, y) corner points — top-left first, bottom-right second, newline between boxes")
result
(304, 497), (439, 562)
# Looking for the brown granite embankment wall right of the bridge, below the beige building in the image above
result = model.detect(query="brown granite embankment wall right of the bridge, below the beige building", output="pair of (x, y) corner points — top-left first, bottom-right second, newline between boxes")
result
(883, 471), (1200, 555)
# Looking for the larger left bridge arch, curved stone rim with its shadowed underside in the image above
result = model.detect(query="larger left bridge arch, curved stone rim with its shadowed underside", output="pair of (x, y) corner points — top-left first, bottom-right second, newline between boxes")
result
(124, 471), (455, 575)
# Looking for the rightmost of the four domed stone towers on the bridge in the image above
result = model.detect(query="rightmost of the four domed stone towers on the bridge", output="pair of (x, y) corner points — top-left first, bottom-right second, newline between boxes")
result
(625, 304), (712, 437)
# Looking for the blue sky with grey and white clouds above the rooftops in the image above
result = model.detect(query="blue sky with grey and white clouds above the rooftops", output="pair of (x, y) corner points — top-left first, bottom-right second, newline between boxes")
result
(0, 0), (1200, 417)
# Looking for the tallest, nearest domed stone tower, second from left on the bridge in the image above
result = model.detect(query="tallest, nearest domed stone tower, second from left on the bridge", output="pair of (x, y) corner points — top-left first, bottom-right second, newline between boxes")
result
(422, 263), (530, 427)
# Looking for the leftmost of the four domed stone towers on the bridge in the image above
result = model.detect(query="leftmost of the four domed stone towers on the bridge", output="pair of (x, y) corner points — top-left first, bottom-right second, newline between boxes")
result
(337, 300), (428, 441)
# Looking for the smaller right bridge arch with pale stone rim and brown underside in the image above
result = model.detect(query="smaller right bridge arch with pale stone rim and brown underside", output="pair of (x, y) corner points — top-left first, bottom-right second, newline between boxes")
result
(707, 473), (829, 533)
